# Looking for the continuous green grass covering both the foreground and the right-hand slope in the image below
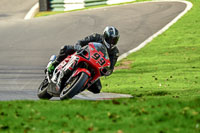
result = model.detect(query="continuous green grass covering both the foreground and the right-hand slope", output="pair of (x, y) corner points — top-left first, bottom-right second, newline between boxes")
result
(0, 0), (200, 133)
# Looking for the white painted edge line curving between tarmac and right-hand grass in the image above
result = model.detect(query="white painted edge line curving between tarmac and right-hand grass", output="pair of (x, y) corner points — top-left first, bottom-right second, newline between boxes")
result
(117, 0), (193, 61)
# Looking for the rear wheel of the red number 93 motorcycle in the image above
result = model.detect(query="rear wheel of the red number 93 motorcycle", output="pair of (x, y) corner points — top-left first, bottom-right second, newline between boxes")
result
(37, 79), (52, 99)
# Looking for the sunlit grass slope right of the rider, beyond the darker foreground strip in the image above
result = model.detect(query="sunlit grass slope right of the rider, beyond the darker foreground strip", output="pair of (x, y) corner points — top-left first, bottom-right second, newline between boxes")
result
(104, 0), (200, 96)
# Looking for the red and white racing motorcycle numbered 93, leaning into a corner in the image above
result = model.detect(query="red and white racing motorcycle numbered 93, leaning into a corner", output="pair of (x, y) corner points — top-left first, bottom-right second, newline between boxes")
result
(37, 42), (110, 100)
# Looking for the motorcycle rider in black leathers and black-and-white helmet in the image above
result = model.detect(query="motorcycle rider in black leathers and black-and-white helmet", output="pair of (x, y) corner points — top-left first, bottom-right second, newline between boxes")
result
(48, 26), (119, 93)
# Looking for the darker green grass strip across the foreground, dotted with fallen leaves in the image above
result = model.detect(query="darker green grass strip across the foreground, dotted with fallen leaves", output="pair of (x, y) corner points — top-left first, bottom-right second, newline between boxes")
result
(0, 97), (200, 133)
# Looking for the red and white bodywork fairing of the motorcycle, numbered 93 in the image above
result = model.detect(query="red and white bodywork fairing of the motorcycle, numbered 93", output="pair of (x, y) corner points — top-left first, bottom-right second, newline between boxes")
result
(46, 42), (110, 95)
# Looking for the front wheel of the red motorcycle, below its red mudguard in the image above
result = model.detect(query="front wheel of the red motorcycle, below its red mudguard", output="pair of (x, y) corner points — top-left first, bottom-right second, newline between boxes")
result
(60, 72), (88, 100)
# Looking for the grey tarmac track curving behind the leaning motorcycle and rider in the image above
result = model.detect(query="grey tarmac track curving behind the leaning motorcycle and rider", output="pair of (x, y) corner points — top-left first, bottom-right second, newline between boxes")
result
(0, 2), (186, 100)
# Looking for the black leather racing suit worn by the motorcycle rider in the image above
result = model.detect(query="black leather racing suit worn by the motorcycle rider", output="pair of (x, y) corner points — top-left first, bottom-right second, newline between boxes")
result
(56, 33), (119, 93)
